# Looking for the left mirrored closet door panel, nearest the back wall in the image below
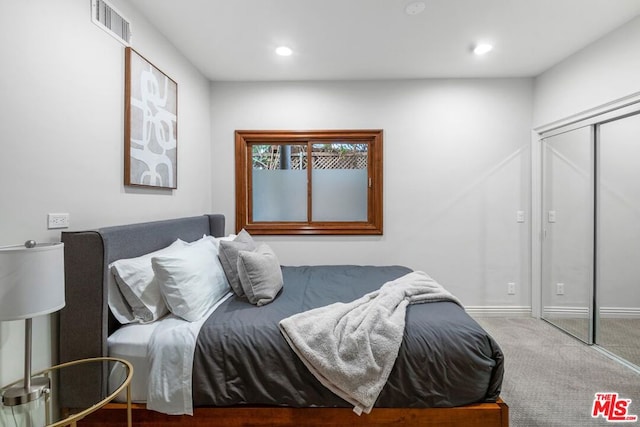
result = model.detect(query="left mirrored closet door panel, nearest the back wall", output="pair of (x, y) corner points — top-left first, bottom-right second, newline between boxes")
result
(542, 126), (594, 342)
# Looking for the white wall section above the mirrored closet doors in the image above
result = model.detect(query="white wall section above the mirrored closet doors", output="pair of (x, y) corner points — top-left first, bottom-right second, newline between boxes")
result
(533, 17), (640, 127)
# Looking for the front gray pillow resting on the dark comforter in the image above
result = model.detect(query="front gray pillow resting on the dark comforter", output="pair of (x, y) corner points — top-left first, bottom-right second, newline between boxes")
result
(238, 243), (282, 306)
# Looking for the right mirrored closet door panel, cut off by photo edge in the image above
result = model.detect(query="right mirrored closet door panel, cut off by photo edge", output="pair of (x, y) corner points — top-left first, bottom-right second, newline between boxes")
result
(596, 114), (640, 366)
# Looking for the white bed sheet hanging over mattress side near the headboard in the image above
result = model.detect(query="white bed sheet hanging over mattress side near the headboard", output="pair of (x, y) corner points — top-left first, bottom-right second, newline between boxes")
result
(107, 292), (233, 415)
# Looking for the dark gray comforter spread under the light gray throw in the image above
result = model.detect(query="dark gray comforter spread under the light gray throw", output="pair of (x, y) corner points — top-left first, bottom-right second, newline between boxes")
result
(193, 266), (503, 408)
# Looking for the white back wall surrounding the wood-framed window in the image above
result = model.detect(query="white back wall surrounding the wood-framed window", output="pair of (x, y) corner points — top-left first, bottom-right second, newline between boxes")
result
(211, 79), (532, 307)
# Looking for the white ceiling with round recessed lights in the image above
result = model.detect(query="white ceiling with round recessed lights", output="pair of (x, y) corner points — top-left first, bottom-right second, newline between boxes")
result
(128, 0), (640, 81)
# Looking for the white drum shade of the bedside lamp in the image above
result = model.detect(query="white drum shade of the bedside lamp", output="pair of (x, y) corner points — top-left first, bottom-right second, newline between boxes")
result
(0, 243), (65, 320)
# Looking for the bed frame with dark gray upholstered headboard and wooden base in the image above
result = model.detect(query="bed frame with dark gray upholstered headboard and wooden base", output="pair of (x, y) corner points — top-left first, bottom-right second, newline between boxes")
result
(59, 215), (509, 427)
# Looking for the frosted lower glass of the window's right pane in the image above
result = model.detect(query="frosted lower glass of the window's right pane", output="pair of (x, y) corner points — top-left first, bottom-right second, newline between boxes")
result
(311, 169), (368, 221)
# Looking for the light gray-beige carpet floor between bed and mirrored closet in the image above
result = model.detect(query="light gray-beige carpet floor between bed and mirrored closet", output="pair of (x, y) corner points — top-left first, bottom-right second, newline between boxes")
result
(476, 318), (640, 427)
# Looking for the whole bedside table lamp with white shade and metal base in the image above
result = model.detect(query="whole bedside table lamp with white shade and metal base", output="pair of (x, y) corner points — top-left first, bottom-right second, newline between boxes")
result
(0, 240), (65, 406)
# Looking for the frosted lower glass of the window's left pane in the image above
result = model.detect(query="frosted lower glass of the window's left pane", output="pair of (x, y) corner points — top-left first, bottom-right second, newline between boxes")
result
(253, 169), (307, 221)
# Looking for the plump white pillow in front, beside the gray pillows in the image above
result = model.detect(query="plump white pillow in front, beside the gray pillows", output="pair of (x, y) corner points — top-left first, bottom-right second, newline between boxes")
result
(151, 238), (231, 322)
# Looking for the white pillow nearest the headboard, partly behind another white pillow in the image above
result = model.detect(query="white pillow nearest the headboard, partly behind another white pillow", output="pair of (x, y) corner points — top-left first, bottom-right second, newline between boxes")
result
(109, 239), (186, 323)
